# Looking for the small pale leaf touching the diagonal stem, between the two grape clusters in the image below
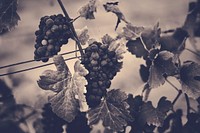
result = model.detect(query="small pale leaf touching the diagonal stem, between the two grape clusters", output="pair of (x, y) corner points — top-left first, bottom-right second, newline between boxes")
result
(77, 26), (90, 45)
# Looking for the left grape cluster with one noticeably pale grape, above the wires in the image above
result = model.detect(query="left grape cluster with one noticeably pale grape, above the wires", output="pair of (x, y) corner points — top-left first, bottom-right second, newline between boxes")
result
(34, 14), (72, 62)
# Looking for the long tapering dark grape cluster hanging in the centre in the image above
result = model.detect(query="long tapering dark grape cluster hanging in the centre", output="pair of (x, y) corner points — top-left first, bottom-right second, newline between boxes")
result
(82, 42), (122, 107)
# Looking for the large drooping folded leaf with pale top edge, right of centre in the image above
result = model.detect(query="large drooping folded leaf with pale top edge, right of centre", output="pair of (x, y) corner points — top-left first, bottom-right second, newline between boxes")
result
(148, 51), (178, 88)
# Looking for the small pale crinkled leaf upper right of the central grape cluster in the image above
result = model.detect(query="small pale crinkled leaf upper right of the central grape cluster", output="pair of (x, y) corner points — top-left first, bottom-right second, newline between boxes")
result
(118, 23), (144, 40)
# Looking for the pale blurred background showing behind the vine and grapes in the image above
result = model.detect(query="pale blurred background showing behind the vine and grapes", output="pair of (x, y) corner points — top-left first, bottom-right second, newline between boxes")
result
(0, 0), (199, 132)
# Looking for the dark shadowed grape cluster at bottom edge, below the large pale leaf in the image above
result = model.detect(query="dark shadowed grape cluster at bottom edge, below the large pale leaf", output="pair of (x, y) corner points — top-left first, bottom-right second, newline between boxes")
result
(42, 103), (66, 133)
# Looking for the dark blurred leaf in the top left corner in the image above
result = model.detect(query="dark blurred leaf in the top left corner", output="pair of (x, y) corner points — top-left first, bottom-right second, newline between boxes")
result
(0, 0), (20, 33)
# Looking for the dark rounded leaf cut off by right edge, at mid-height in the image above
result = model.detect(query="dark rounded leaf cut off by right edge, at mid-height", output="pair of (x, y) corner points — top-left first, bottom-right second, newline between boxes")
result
(180, 62), (200, 99)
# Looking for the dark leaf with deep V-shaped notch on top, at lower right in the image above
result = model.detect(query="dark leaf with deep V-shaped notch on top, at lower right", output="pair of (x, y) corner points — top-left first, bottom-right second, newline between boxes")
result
(139, 97), (172, 126)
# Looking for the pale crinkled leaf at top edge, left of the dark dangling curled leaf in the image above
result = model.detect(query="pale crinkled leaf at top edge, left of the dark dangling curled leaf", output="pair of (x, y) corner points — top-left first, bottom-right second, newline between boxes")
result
(79, 0), (97, 19)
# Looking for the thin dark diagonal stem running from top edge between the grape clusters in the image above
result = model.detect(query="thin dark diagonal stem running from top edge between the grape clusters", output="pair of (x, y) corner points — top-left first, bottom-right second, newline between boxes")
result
(57, 0), (84, 57)
